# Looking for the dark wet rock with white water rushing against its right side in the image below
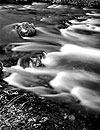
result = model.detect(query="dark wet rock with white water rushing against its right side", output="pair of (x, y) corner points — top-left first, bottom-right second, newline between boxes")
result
(18, 51), (46, 68)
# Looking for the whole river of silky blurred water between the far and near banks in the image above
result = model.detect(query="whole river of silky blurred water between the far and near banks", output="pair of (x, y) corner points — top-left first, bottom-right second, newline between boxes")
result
(0, 3), (100, 112)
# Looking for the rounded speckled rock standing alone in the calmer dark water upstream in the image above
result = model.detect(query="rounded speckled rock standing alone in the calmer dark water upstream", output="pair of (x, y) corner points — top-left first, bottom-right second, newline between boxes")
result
(14, 22), (36, 38)
